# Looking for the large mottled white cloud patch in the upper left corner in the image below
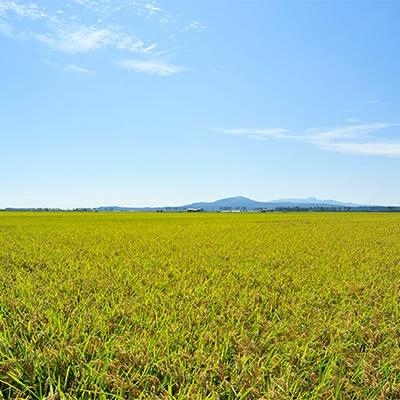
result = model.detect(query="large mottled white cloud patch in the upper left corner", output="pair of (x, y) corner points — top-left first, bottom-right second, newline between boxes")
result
(0, 0), (175, 54)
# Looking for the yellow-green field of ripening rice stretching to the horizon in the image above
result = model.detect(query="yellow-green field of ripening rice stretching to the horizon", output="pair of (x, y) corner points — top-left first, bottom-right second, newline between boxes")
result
(0, 212), (400, 399)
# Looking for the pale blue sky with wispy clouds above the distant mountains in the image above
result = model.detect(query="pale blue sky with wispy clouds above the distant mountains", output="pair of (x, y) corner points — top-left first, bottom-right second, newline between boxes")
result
(0, 0), (400, 208)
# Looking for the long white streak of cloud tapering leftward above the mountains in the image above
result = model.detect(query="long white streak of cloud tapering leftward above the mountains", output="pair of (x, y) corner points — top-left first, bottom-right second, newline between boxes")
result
(212, 122), (400, 157)
